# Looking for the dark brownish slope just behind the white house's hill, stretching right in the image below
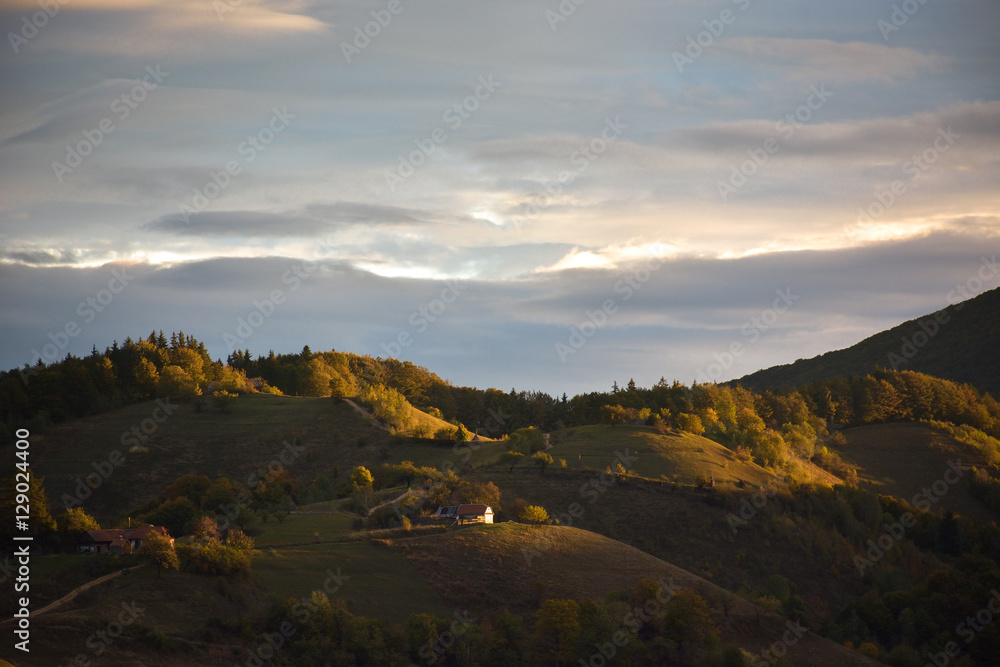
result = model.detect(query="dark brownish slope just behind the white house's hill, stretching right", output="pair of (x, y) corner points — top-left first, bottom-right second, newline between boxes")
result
(470, 468), (865, 609)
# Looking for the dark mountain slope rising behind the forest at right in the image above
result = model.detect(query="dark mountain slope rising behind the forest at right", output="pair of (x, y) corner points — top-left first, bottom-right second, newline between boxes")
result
(735, 288), (1000, 396)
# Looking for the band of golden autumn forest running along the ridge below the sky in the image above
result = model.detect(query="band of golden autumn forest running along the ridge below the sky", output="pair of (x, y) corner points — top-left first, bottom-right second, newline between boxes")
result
(0, 331), (1000, 478)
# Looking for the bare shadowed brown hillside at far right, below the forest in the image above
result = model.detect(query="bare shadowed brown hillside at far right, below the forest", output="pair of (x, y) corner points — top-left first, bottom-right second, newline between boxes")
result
(835, 424), (1000, 523)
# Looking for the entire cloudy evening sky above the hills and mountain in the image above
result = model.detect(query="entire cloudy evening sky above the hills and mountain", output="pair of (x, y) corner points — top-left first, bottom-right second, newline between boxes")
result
(0, 0), (1000, 395)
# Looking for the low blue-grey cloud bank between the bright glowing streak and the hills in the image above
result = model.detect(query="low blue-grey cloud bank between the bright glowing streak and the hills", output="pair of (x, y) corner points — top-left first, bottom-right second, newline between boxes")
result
(0, 230), (1000, 393)
